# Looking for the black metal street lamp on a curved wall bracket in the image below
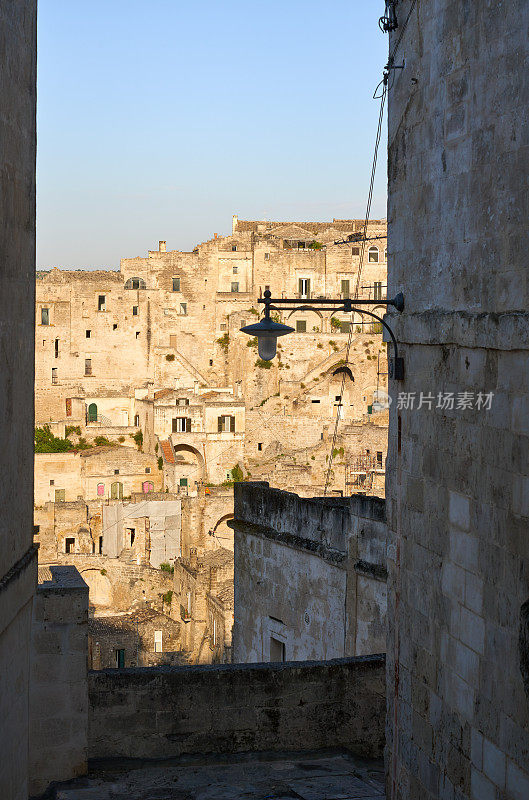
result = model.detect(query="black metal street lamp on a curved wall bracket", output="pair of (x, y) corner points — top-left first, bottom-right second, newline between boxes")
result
(241, 289), (404, 381)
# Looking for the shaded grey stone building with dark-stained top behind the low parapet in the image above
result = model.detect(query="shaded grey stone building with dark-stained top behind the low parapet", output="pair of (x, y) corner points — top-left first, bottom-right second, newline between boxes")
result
(232, 483), (386, 663)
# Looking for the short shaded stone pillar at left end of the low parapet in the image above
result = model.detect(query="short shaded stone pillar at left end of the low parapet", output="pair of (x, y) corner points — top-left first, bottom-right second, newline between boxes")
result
(29, 566), (88, 795)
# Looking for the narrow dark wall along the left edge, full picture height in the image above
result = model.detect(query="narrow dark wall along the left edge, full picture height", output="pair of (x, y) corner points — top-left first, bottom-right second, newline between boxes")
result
(0, 0), (37, 800)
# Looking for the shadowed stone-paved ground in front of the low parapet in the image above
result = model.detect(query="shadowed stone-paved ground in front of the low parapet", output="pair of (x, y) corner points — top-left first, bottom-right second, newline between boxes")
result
(53, 753), (384, 800)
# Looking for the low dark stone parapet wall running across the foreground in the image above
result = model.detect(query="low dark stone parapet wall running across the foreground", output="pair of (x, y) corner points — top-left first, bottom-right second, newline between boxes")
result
(88, 656), (385, 759)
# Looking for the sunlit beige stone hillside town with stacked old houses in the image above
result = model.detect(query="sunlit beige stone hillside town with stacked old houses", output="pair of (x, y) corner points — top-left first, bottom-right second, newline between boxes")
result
(35, 216), (388, 667)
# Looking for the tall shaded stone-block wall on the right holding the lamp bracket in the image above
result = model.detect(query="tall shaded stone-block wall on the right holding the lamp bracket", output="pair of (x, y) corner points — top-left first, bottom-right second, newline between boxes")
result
(387, 0), (529, 800)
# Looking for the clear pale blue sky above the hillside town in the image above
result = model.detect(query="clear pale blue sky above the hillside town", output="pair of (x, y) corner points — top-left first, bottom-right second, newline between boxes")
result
(37, 0), (388, 269)
